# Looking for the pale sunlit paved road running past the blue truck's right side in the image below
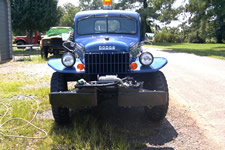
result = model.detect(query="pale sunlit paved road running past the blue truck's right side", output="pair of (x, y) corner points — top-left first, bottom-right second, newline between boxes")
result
(145, 48), (225, 149)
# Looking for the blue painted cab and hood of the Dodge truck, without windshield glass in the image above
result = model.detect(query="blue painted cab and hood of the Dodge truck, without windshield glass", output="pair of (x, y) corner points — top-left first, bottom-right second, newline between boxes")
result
(74, 10), (141, 52)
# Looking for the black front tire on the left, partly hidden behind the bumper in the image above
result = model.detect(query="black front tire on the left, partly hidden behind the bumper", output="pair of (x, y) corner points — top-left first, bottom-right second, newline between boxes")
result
(51, 72), (71, 124)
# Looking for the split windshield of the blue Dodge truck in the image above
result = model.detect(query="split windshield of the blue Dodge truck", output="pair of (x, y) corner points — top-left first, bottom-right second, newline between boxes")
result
(77, 17), (137, 35)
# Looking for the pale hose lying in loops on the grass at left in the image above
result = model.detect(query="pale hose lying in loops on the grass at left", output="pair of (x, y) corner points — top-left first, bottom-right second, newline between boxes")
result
(0, 96), (48, 139)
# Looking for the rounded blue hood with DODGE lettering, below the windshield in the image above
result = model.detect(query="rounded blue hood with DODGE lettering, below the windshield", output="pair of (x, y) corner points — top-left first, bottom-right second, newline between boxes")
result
(75, 35), (138, 53)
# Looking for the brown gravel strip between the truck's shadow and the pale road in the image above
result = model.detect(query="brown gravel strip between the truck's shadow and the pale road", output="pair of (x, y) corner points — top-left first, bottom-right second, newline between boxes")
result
(162, 98), (219, 150)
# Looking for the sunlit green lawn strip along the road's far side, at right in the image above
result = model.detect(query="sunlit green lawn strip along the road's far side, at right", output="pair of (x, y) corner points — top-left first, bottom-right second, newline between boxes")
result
(146, 43), (225, 60)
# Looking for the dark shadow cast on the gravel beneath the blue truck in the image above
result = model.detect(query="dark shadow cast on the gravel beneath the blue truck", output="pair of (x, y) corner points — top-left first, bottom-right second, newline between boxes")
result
(90, 105), (178, 145)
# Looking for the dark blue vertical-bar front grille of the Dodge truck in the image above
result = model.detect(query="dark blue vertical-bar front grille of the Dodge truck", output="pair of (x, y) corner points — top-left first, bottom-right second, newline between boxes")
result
(85, 53), (129, 74)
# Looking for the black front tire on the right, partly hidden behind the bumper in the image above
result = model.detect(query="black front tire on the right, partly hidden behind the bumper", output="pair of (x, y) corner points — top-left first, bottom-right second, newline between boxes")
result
(144, 71), (169, 121)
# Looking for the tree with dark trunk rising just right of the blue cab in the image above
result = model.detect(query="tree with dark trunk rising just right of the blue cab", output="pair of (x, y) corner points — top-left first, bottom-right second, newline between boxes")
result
(115, 0), (181, 37)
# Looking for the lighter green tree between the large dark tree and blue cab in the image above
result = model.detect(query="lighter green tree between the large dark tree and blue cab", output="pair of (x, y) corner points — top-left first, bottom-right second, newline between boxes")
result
(60, 3), (80, 28)
